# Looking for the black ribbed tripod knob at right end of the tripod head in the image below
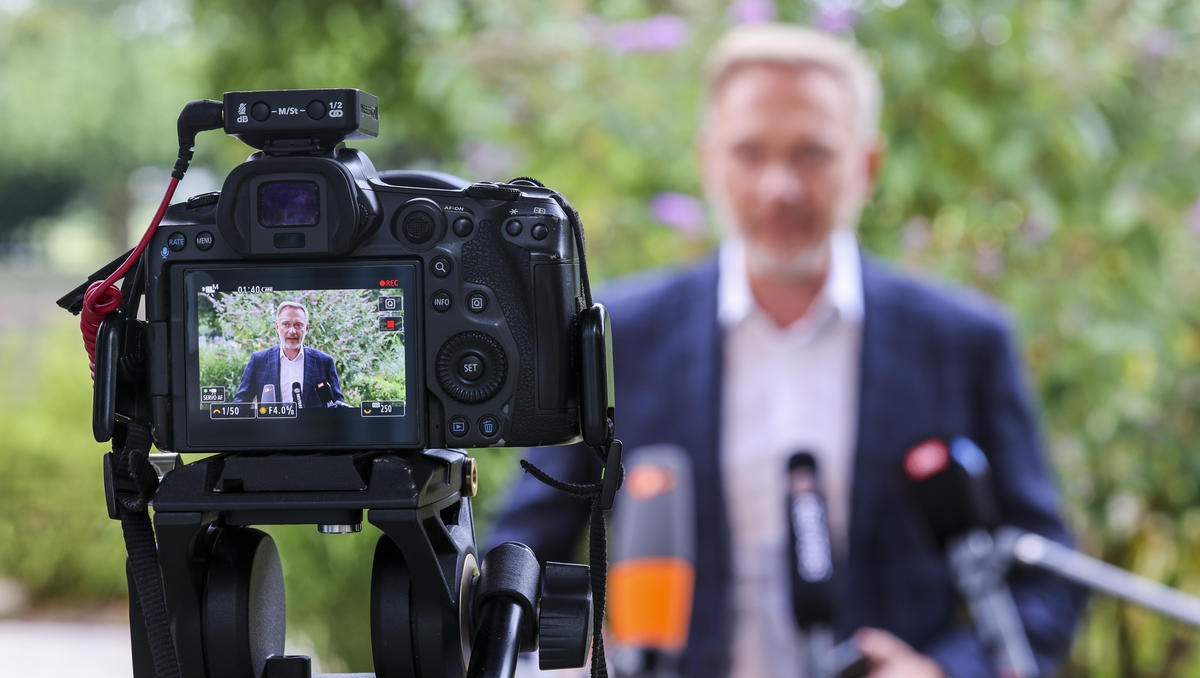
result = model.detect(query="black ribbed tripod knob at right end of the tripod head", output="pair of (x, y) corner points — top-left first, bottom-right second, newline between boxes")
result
(538, 563), (592, 671)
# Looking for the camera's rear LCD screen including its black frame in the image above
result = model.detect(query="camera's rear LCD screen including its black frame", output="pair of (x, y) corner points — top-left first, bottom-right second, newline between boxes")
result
(177, 263), (422, 451)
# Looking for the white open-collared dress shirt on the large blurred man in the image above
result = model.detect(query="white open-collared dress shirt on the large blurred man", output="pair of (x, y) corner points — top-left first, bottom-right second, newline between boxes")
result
(716, 230), (864, 678)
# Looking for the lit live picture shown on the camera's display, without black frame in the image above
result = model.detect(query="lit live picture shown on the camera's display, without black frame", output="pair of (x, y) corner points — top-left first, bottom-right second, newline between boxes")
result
(196, 286), (408, 421)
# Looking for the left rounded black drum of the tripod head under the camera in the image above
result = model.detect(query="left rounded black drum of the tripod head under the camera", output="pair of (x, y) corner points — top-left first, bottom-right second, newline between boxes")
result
(204, 528), (286, 678)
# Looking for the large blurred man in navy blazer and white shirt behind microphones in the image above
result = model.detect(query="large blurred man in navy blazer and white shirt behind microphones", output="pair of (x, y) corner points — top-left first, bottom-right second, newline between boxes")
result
(493, 24), (1080, 678)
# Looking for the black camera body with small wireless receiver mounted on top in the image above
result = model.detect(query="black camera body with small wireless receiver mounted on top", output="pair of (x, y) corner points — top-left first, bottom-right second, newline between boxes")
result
(143, 90), (583, 452)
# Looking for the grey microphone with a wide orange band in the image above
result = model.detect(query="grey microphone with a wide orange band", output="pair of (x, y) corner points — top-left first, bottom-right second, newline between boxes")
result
(608, 445), (696, 678)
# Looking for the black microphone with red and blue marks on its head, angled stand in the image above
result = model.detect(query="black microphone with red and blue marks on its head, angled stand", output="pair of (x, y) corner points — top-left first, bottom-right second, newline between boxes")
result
(904, 437), (1038, 678)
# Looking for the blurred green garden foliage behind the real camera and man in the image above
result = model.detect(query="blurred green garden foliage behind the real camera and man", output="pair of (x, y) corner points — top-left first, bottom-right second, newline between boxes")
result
(0, 0), (1200, 677)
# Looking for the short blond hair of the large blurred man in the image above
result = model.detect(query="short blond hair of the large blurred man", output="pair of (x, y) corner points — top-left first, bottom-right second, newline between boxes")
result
(704, 23), (883, 142)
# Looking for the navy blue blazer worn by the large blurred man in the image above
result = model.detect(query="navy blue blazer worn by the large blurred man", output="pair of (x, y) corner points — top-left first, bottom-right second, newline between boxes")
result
(490, 257), (1082, 678)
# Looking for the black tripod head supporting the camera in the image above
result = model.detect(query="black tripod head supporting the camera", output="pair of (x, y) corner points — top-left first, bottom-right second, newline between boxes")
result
(114, 450), (592, 678)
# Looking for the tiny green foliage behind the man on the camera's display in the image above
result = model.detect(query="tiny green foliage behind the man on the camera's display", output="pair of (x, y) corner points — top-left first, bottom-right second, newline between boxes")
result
(199, 289), (408, 404)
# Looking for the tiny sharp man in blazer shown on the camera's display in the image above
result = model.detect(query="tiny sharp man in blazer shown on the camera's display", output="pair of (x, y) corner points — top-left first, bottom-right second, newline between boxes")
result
(234, 301), (343, 407)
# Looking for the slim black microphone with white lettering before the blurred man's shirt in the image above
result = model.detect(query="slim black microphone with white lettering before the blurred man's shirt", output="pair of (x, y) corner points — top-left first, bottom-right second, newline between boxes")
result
(787, 451), (869, 678)
